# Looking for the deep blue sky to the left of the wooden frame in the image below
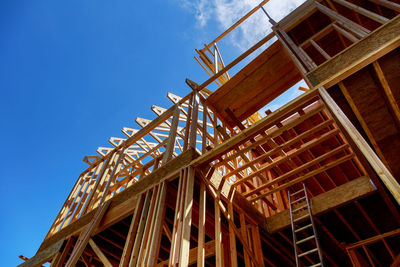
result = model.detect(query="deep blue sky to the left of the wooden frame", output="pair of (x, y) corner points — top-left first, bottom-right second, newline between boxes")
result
(0, 0), (299, 266)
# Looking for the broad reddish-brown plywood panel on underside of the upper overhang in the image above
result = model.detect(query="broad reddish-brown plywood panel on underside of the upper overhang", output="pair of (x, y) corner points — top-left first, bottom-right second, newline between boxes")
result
(207, 41), (301, 127)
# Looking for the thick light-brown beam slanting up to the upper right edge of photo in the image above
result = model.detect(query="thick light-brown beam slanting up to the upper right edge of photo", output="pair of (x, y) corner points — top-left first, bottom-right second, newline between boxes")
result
(306, 15), (400, 88)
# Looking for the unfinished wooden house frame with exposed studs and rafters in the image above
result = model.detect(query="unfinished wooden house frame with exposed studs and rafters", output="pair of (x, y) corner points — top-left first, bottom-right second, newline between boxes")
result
(20, 0), (400, 267)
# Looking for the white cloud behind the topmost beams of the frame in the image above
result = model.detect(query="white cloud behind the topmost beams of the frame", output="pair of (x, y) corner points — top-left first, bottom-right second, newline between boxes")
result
(180, 0), (304, 51)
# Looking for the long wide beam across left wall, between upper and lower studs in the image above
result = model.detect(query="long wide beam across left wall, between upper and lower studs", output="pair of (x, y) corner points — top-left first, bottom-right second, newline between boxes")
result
(37, 149), (199, 253)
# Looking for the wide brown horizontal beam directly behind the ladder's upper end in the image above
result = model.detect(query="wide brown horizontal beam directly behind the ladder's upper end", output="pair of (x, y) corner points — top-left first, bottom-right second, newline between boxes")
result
(266, 176), (376, 233)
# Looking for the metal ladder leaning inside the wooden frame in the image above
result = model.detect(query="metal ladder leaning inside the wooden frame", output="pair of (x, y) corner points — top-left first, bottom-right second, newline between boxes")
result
(288, 183), (324, 267)
